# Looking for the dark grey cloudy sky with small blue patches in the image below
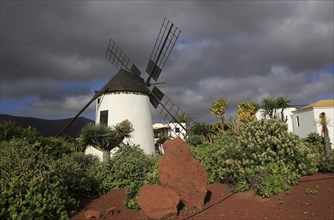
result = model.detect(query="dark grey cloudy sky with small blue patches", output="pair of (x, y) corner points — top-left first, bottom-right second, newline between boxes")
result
(0, 1), (334, 122)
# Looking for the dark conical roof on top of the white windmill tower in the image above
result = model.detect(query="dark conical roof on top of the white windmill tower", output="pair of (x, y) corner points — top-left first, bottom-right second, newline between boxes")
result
(100, 69), (150, 94)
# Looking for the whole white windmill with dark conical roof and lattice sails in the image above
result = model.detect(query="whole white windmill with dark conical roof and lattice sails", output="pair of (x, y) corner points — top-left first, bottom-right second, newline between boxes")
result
(57, 18), (195, 154)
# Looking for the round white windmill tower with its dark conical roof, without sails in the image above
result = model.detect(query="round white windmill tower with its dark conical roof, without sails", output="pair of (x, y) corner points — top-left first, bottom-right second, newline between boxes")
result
(96, 69), (155, 154)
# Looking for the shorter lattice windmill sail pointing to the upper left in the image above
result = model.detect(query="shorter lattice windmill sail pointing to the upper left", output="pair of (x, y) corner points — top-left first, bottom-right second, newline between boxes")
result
(106, 39), (141, 76)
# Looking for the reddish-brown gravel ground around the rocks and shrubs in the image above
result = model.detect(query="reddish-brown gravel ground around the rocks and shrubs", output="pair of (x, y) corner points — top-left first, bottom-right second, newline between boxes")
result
(72, 173), (334, 220)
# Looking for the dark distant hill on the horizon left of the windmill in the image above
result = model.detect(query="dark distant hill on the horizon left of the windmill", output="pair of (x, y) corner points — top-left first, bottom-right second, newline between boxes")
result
(0, 114), (94, 137)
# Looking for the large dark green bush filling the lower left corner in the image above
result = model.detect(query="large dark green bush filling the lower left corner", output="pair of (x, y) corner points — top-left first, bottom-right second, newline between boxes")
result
(0, 137), (99, 219)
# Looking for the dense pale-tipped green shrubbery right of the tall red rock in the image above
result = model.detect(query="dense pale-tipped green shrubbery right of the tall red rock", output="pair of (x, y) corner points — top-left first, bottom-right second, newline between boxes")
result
(187, 97), (334, 197)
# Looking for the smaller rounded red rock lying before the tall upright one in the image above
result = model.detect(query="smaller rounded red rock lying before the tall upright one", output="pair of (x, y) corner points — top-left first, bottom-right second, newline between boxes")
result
(137, 184), (180, 219)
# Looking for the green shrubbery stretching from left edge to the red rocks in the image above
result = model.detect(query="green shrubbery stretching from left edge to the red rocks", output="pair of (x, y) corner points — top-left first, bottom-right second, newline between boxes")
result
(0, 122), (158, 219)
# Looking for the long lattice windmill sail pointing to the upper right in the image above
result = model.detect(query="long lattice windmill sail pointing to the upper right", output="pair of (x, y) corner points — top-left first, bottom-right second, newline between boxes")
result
(146, 18), (181, 86)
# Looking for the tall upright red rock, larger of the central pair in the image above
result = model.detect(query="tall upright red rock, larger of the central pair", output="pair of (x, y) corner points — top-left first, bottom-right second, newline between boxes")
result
(158, 138), (208, 209)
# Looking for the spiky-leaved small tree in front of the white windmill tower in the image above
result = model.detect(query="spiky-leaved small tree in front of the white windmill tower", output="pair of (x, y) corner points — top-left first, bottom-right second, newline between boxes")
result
(80, 120), (133, 162)
